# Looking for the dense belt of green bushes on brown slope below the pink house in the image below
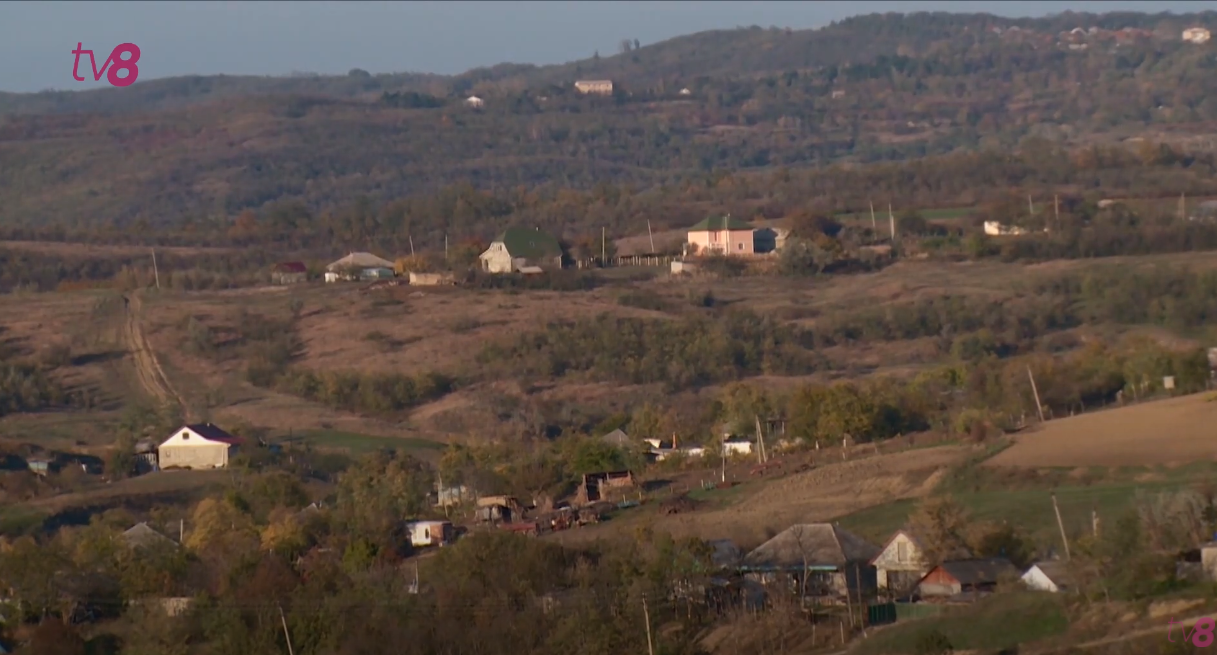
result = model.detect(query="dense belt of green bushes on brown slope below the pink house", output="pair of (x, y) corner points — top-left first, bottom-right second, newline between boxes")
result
(478, 312), (820, 388)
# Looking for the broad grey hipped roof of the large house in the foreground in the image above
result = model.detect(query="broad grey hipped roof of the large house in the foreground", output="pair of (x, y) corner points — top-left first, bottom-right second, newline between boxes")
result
(744, 524), (879, 570)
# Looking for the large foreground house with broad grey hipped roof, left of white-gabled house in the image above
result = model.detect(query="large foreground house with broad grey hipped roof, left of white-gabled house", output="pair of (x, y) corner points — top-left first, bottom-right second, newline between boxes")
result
(740, 524), (879, 598)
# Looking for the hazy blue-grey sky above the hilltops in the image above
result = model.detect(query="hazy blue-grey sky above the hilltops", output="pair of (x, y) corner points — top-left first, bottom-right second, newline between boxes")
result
(0, 0), (1217, 91)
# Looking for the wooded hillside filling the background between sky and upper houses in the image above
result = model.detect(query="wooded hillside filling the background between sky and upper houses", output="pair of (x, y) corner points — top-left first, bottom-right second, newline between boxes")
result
(0, 12), (1217, 239)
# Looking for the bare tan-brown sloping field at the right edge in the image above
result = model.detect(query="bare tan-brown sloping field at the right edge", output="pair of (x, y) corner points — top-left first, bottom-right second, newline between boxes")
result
(989, 393), (1217, 466)
